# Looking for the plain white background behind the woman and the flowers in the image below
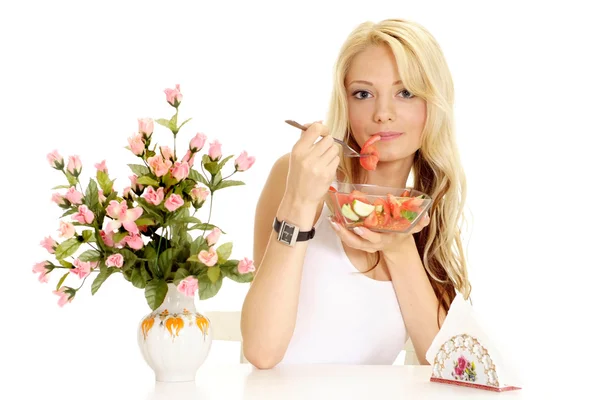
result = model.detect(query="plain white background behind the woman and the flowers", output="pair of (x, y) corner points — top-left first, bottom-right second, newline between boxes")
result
(0, 0), (600, 395)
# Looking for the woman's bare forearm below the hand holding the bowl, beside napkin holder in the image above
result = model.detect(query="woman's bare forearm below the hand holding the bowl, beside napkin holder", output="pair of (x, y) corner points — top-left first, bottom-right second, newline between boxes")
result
(383, 236), (446, 365)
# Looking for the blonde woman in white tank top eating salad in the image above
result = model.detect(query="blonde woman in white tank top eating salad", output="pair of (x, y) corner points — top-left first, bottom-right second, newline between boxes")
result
(241, 19), (470, 369)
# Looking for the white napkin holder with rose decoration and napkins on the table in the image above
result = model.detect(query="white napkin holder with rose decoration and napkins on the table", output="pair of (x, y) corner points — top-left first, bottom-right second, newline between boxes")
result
(427, 294), (521, 392)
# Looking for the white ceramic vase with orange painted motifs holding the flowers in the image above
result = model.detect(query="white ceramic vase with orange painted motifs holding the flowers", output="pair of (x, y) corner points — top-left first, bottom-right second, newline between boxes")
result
(138, 283), (212, 382)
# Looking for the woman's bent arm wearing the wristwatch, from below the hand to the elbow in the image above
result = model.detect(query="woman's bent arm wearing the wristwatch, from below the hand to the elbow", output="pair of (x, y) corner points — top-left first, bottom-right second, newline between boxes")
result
(241, 155), (318, 368)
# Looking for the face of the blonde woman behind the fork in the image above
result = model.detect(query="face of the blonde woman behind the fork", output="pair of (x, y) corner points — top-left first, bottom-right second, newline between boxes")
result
(345, 45), (427, 162)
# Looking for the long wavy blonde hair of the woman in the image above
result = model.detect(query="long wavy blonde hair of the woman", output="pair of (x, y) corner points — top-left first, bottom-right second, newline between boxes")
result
(327, 19), (471, 321)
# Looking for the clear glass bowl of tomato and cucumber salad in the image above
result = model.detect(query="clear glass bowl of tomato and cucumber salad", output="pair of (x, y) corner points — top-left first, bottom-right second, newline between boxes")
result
(325, 182), (432, 232)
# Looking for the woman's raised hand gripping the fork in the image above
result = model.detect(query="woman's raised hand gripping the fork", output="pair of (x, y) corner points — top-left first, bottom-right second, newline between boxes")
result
(284, 122), (340, 205)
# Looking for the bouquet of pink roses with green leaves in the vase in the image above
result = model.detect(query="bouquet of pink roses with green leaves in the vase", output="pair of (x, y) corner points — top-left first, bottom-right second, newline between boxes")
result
(33, 85), (255, 310)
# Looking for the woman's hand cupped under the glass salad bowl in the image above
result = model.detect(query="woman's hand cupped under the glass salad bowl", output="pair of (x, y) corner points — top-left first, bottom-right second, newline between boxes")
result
(329, 213), (430, 253)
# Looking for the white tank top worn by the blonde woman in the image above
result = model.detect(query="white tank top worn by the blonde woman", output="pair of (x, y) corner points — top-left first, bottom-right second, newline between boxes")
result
(280, 205), (407, 365)
